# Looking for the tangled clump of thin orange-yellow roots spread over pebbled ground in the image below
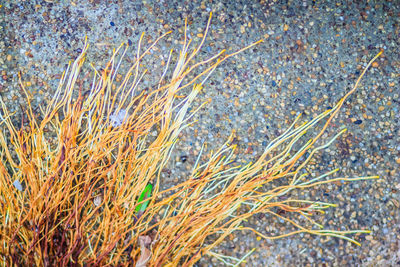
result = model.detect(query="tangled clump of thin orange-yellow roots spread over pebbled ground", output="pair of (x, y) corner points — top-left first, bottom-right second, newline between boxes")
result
(0, 15), (381, 266)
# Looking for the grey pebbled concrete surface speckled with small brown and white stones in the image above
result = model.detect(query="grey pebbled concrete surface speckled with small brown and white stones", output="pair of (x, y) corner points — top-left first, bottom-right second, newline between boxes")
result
(0, 0), (400, 266)
